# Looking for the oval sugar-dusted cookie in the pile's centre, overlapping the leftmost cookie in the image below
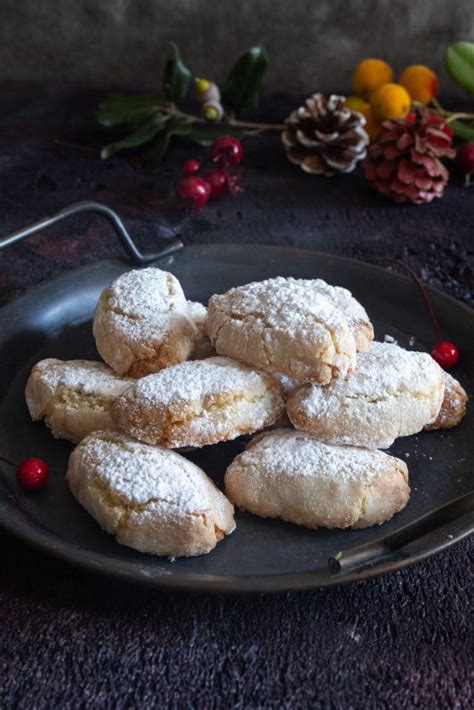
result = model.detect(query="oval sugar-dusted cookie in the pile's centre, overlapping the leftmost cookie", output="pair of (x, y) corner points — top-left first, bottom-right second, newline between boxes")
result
(112, 357), (284, 448)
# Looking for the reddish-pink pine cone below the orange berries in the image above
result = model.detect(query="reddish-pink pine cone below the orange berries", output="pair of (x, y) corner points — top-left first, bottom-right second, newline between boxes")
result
(362, 111), (455, 205)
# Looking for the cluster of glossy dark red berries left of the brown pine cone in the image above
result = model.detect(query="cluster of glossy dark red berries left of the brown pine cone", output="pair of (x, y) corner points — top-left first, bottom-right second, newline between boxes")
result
(176, 136), (244, 213)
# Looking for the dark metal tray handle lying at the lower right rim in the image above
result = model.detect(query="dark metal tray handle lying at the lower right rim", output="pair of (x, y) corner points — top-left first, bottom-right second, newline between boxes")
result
(328, 491), (474, 575)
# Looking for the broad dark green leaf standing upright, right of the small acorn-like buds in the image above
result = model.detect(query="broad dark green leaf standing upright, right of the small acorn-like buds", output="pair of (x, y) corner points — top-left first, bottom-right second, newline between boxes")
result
(222, 45), (268, 113)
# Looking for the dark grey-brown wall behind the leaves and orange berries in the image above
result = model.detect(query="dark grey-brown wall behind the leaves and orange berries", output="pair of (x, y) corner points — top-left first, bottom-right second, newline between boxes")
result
(0, 0), (474, 92)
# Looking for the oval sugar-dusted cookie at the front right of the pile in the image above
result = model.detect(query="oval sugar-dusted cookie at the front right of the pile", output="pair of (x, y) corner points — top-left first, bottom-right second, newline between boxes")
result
(225, 429), (410, 528)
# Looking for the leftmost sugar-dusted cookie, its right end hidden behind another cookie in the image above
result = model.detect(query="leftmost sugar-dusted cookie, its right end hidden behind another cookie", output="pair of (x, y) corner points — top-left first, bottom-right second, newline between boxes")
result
(25, 358), (135, 442)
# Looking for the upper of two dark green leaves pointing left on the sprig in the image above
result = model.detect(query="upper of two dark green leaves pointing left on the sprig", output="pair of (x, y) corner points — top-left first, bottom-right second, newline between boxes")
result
(96, 93), (163, 128)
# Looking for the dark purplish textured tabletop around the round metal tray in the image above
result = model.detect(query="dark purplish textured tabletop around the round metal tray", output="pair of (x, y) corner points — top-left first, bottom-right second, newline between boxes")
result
(0, 90), (474, 708)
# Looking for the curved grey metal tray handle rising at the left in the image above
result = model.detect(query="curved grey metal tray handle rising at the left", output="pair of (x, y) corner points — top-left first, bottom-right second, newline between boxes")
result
(0, 202), (184, 265)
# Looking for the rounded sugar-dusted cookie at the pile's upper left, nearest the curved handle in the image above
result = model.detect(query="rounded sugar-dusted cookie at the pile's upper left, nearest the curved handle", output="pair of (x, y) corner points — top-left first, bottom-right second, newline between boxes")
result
(93, 268), (199, 377)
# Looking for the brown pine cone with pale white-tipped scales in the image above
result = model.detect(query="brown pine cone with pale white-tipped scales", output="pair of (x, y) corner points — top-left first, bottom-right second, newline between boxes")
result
(281, 94), (369, 175)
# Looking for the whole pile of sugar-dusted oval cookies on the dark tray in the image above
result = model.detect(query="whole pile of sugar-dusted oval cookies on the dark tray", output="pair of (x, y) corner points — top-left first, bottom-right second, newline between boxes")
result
(26, 268), (467, 556)
